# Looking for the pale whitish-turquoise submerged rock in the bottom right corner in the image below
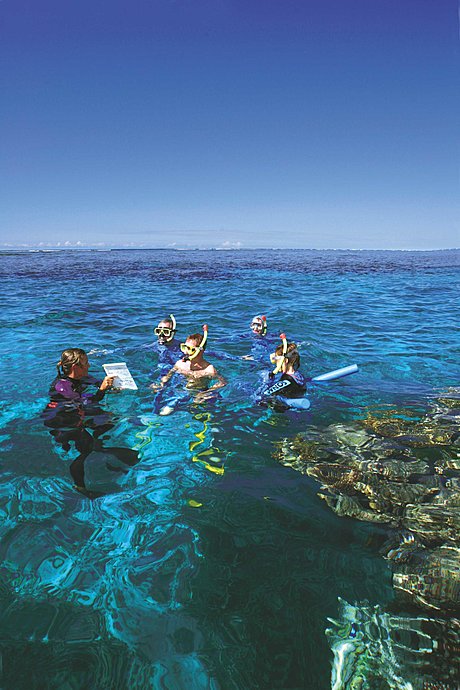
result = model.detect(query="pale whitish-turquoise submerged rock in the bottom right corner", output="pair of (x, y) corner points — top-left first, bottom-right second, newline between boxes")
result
(326, 599), (460, 690)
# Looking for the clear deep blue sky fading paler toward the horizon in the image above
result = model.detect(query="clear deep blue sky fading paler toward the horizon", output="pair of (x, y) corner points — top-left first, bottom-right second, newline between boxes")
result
(0, 0), (460, 249)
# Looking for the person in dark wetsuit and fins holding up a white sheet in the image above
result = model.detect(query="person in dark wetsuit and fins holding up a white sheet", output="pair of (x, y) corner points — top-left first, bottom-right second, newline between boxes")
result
(42, 347), (138, 492)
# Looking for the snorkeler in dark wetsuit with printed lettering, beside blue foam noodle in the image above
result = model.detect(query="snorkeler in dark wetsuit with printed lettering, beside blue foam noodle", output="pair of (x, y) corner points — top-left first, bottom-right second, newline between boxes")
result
(259, 334), (310, 411)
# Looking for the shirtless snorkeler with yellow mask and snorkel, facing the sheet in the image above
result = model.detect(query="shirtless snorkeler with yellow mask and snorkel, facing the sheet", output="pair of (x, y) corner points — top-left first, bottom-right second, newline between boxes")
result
(151, 325), (227, 415)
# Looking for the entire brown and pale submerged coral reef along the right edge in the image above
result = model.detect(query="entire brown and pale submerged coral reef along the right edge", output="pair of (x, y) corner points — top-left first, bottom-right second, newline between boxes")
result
(276, 391), (460, 676)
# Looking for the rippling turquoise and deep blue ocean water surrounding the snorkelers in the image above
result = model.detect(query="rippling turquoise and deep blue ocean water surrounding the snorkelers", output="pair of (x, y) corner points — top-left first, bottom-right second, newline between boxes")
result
(0, 250), (460, 690)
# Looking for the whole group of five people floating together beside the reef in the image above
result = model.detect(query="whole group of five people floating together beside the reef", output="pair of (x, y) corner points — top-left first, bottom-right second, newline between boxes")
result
(43, 314), (307, 494)
